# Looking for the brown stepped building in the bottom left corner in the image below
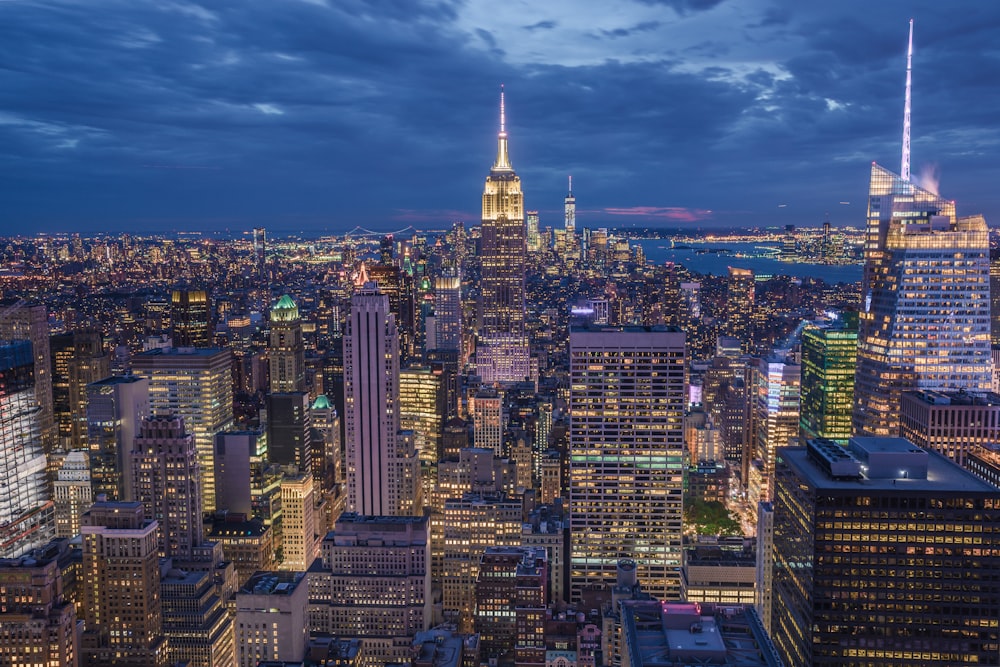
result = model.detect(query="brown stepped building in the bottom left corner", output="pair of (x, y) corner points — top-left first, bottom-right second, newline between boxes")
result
(0, 552), (80, 667)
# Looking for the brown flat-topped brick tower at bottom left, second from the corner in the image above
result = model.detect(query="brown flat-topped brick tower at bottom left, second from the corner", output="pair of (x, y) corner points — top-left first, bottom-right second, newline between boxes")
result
(80, 502), (168, 667)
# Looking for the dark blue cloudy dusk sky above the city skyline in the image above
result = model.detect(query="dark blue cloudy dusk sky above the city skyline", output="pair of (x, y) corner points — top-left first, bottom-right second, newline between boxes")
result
(0, 0), (1000, 234)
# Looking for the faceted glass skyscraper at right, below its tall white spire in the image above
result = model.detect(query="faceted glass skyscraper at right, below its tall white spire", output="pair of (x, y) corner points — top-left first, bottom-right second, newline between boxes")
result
(853, 163), (992, 435)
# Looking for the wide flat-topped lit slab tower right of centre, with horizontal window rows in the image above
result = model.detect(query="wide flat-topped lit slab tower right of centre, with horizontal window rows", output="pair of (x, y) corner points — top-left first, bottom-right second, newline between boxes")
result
(569, 327), (686, 601)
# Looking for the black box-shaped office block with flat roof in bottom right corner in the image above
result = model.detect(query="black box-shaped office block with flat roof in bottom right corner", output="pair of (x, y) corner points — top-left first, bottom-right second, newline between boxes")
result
(771, 437), (1000, 667)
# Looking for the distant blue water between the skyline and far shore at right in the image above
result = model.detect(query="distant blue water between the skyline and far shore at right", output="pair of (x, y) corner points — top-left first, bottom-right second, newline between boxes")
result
(632, 239), (862, 284)
